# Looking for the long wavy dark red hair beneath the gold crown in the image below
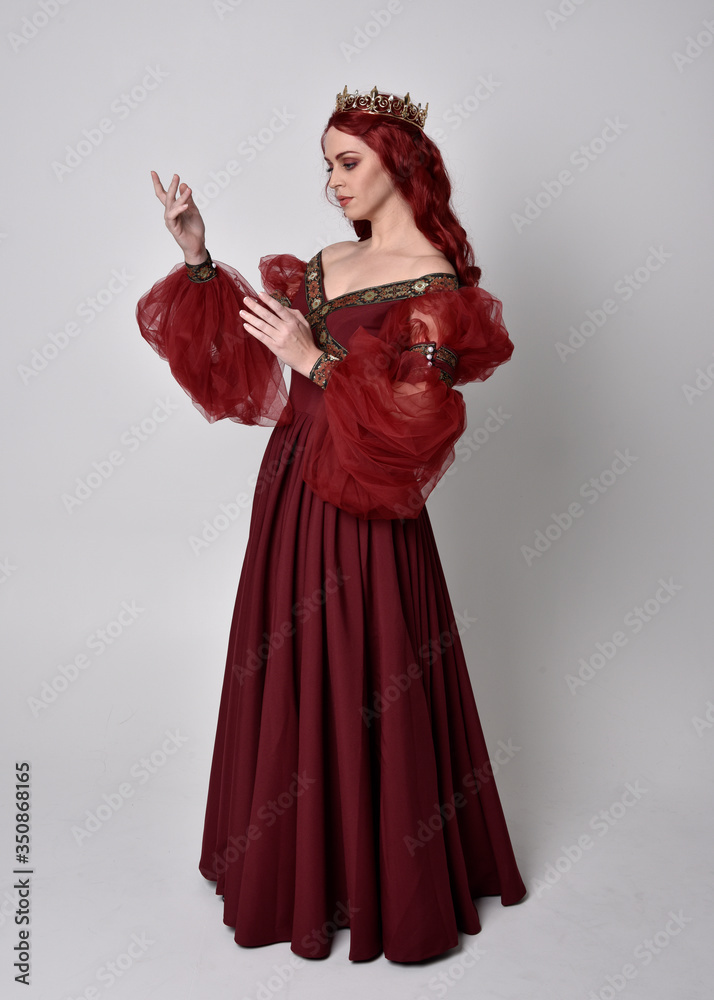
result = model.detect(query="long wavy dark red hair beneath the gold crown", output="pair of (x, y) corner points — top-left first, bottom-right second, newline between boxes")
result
(321, 111), (481, 285)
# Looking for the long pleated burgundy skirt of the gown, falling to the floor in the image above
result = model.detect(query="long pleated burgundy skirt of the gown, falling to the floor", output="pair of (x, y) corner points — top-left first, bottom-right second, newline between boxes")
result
(200, 411), (526, 962)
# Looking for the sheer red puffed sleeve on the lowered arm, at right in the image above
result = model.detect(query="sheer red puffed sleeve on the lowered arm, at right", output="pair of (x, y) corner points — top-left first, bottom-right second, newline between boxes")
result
(303, 286), (513, 518)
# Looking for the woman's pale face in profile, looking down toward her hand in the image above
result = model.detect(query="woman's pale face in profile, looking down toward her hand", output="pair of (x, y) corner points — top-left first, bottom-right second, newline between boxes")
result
(325, 127), (399, 220)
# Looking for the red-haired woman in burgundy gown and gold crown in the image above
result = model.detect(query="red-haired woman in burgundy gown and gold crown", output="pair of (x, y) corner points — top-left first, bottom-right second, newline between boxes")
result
(137, 88), (526, 962)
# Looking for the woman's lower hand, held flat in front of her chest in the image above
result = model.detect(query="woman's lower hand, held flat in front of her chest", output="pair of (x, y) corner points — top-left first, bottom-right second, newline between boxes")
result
(240, 292), (322, 377)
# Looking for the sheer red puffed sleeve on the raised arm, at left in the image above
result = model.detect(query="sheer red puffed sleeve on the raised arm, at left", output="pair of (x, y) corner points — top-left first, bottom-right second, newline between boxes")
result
(136, 254), (305, 426)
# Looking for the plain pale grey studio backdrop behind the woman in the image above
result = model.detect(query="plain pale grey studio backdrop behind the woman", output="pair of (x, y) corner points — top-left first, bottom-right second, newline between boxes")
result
(0, 0), (714, 1000)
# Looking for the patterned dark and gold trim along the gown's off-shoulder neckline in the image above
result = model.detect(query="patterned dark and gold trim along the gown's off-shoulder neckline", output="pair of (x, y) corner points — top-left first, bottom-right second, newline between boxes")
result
(305, 250), (459, 360)
